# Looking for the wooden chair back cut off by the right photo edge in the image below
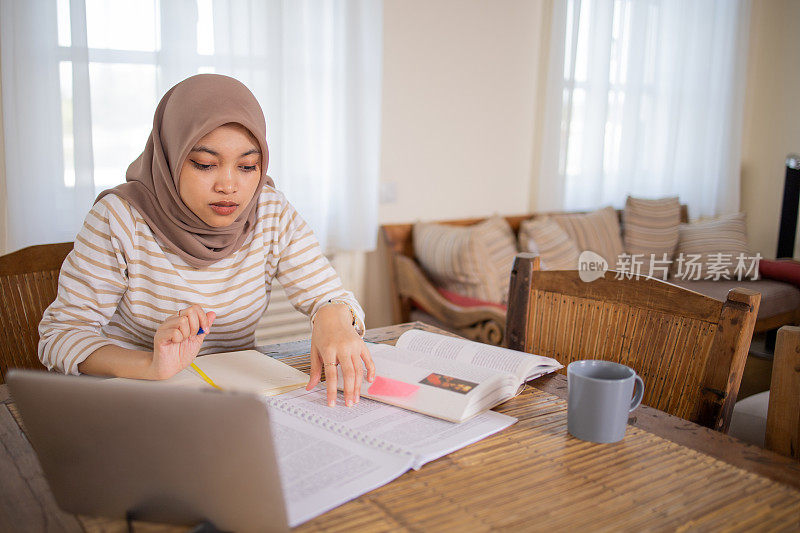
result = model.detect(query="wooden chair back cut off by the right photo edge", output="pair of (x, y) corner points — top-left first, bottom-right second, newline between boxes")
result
(764, 326), (800, 460)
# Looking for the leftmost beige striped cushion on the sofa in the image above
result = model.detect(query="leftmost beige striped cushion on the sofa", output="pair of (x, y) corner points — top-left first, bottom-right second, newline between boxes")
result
(413, 217), (517, 303)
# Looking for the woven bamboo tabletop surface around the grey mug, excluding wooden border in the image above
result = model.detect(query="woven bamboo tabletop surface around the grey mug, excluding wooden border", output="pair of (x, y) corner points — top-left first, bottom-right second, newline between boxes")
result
(299, 389), (800, 531)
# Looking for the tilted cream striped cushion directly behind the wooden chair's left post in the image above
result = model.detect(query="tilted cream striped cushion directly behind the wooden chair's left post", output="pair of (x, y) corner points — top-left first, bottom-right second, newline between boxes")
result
(519, 217), (580, 270)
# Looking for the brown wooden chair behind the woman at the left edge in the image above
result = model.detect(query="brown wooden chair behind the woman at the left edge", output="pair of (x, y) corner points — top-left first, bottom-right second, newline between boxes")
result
(0, 242), (72, 384)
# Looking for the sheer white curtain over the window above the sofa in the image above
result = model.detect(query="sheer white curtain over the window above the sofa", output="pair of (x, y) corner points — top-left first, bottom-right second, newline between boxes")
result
(536, 0), (750, 217)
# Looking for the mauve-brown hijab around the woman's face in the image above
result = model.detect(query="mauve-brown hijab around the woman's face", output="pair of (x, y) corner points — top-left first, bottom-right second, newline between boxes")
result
(95, 74), (274, 268)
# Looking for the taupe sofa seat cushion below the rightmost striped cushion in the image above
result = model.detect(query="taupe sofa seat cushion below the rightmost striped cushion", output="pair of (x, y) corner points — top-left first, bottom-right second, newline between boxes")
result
(669, 278), (800, 320)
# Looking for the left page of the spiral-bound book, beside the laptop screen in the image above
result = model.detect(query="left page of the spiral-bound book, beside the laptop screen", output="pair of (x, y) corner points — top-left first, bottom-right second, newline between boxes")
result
(269, 407), (411, 527)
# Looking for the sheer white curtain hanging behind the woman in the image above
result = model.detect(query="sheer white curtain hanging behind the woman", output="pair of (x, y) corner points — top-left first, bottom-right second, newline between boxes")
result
(0, 0), (383, 252)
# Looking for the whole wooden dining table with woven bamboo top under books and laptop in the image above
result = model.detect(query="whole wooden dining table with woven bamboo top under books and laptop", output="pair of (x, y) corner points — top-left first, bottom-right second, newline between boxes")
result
(0, 323), (800, 531)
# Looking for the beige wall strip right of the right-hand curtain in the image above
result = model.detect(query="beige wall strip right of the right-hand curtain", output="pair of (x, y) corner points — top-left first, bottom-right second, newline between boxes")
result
(742, 0), (800, 257)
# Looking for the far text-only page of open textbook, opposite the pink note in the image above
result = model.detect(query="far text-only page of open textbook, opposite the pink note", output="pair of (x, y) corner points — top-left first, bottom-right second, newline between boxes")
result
(396, 329), (563, 382)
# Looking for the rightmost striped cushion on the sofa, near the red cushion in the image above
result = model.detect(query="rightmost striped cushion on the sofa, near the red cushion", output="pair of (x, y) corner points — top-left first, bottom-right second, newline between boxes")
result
(672, 213), (750, 279)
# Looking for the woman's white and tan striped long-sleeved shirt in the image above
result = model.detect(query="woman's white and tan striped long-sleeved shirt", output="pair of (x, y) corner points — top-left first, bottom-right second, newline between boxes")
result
(39, 186), (364, 374)
